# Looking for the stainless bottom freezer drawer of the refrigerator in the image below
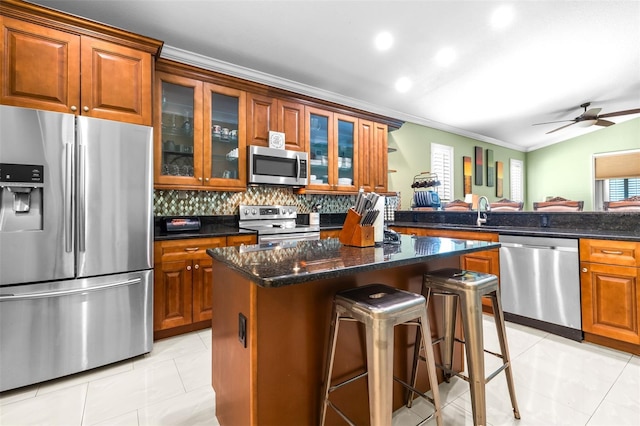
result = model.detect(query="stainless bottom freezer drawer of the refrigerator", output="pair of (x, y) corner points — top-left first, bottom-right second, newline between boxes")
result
(0, 271), (153, 392)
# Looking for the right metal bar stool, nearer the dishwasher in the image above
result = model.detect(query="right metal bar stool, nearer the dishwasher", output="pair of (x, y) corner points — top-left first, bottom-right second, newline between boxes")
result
(412, 269), (520, 425)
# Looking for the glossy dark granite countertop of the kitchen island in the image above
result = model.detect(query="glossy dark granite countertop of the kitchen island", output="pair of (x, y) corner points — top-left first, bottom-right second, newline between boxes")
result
(207, 235), (500, 287)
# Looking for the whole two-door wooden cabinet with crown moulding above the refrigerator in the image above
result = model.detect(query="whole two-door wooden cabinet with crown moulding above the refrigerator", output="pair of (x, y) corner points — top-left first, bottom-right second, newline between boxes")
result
(0, 0), (162, 125)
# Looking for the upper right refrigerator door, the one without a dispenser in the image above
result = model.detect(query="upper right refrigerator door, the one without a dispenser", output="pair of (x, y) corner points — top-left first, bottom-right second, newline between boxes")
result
(76, 117), (153, 277)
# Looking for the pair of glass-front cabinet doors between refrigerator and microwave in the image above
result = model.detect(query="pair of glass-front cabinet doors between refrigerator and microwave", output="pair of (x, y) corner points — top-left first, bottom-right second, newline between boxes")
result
(154, 71), (247, 190)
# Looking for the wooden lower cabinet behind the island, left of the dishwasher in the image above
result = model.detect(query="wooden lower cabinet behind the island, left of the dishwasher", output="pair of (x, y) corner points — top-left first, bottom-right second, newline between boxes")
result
(393, 226), (500, 313)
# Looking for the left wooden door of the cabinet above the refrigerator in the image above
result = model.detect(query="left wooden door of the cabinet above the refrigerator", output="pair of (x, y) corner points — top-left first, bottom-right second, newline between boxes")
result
(0, 16), (80, 113)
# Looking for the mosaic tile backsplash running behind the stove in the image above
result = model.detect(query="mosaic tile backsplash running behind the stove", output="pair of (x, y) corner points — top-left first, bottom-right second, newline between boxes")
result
(153, 186), (355, 216)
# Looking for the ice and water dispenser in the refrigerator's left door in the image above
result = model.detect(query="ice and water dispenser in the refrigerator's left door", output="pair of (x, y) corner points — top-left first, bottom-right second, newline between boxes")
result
(0, 163), (44, 232)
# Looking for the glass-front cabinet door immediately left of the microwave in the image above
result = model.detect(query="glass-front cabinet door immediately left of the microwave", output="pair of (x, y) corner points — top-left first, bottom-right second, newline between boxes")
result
(204, 83), (247, 190)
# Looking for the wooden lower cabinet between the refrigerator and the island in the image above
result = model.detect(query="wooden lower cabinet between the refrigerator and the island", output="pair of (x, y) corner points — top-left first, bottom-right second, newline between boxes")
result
(153, 234), (256, 339)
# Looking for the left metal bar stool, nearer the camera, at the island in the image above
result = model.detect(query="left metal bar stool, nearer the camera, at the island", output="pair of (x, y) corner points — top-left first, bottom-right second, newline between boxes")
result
(320, 284), (442, 426)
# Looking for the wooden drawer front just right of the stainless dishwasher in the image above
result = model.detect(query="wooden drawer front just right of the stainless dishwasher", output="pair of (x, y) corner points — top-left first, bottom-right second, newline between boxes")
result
(580, 239), (640, 267)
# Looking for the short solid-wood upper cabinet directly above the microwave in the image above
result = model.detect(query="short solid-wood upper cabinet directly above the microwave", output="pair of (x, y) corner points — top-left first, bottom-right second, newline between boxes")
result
(247, 93), (305, 151)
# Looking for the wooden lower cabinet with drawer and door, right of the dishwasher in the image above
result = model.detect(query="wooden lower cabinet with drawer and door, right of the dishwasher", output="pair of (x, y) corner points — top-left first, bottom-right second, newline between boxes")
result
(580, 239), (640, 355)
